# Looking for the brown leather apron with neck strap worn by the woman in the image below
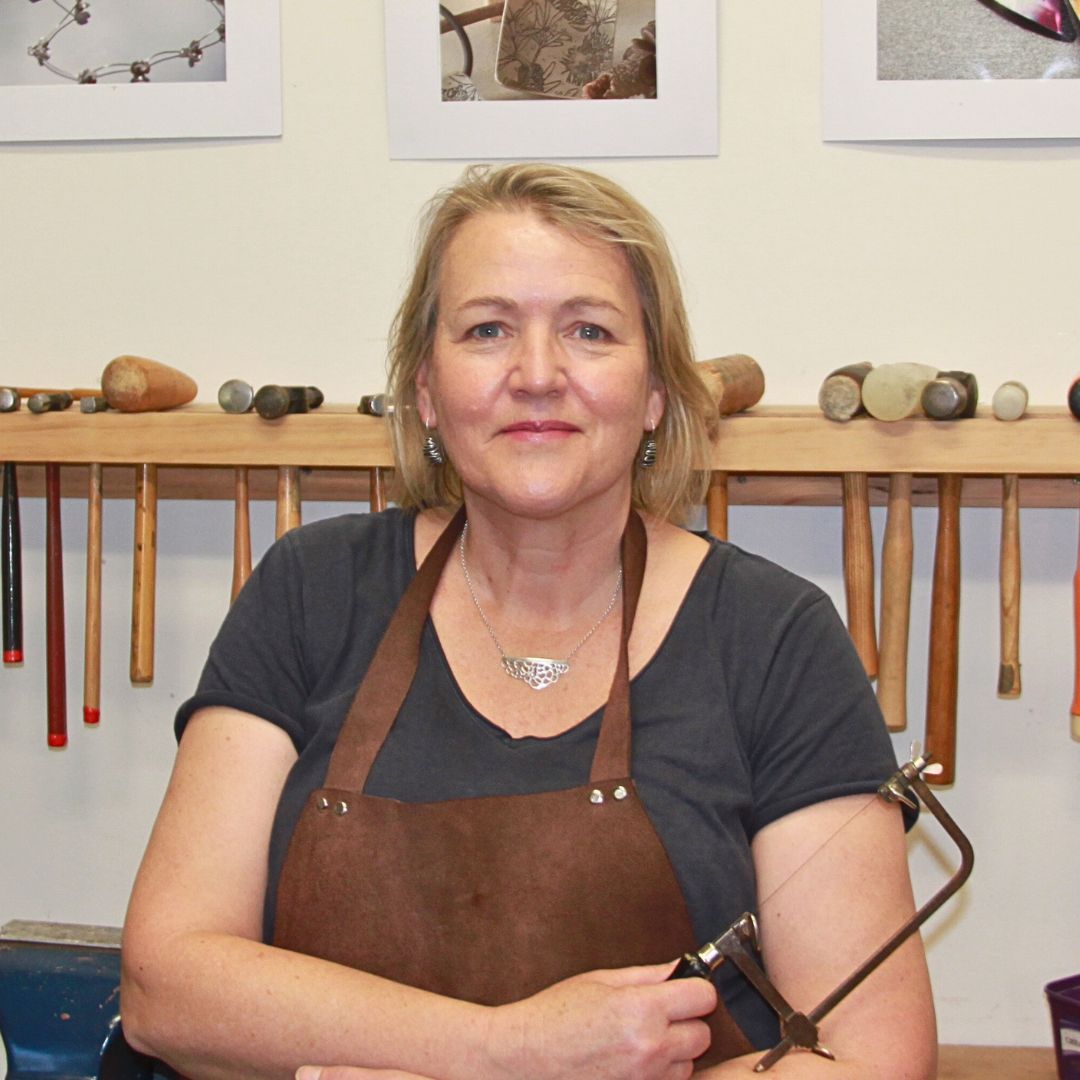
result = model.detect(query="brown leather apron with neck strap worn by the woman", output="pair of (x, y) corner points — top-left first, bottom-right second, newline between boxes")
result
(274, 511), (752, 1064)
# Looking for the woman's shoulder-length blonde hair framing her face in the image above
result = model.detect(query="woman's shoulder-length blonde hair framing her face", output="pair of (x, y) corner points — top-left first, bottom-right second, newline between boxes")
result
(388, 163), (716, 522)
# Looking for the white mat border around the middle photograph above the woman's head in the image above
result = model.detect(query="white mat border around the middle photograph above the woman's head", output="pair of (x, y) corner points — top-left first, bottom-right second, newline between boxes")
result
(383, 0), (718, 161)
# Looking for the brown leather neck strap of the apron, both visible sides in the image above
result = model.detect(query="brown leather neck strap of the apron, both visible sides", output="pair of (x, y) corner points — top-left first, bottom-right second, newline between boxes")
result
(325, 507), (647, 791)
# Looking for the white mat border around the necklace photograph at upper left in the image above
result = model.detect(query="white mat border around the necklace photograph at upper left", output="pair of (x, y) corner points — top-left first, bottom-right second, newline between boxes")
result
(0, 0), (282, 143)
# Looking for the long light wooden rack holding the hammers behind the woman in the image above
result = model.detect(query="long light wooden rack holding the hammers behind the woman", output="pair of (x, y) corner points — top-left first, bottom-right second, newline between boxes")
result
(0, 405), (1080, 507)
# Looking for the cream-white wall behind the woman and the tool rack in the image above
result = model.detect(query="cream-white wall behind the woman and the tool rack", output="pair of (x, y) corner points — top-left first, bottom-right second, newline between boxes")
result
(0, 0), (1080, 1043)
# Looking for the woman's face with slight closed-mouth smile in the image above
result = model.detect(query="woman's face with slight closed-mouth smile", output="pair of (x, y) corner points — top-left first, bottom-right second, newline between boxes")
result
(417, 211), (664, 517)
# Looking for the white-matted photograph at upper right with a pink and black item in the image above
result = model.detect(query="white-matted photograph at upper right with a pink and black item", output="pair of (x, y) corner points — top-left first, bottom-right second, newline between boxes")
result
(822, 0), (1080, 141)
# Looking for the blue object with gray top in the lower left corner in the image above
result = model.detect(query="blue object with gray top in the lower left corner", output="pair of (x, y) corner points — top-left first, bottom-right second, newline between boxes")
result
(0, 921), (166, 1080)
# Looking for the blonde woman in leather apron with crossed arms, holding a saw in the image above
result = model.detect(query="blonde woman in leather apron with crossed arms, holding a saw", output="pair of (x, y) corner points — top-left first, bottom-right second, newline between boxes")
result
(123, 165), (935, 1080)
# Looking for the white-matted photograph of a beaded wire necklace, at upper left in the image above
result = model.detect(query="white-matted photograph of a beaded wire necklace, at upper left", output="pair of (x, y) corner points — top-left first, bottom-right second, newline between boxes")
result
(0, 0), (281, 143)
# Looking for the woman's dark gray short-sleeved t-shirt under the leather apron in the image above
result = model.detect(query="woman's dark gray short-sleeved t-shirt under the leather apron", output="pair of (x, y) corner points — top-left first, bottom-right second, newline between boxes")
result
(176, 509), (895, 1047)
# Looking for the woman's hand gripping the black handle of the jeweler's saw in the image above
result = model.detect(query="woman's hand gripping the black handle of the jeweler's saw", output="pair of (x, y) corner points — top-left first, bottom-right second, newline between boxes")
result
(491, 963), (716, 1080)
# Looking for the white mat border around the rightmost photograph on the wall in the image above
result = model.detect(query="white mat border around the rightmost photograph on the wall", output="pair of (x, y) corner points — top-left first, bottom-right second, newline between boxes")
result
(822, 0), (1080, 141)
